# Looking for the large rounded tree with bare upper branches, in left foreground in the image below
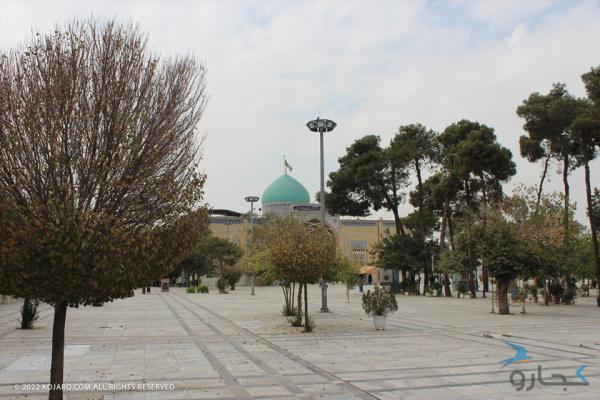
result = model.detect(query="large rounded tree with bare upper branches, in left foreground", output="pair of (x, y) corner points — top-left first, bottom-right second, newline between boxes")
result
(0, 20), (206, 399)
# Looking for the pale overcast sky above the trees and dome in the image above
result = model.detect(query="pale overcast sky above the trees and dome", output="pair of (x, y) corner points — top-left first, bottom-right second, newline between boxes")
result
(0, 0), (600, 222)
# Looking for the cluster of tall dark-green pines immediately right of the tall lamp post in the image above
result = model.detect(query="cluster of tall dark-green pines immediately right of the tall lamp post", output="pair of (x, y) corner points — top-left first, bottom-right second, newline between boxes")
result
(326, 120), (516, 293)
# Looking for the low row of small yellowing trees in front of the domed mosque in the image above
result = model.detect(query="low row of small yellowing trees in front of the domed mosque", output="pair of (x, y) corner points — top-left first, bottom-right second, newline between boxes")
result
(171, 215), (360, 331)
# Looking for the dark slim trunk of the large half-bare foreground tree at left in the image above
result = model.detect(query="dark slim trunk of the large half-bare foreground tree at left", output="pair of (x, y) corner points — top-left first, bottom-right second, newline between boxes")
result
(48, 303), (67, 400)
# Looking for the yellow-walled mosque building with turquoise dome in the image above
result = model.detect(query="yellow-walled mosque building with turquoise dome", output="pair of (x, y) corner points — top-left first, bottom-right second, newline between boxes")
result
(209, 173), (395, 284)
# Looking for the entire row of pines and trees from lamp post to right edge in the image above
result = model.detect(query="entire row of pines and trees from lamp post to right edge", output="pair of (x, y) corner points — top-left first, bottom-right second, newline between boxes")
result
(325, 68), (600, 306)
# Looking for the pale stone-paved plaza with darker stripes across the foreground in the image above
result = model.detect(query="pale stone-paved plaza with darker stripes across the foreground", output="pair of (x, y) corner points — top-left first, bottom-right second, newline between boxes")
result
(0, 286), (600, 400)
